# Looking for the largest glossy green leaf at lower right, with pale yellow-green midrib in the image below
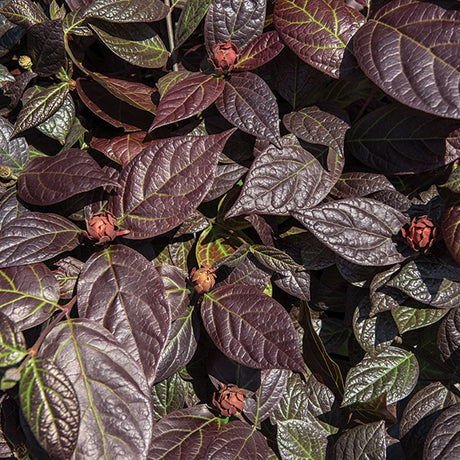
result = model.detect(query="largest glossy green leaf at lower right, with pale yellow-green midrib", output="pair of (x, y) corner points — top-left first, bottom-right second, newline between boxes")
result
(342, 347), (419, 406)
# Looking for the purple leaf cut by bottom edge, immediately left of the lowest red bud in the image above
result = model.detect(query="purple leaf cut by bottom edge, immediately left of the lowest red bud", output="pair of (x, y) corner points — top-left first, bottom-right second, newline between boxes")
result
(148, 404), (220, 460)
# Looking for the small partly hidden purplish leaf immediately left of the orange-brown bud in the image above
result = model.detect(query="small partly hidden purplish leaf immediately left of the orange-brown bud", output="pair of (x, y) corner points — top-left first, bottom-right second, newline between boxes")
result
(156, 264), (190, 321)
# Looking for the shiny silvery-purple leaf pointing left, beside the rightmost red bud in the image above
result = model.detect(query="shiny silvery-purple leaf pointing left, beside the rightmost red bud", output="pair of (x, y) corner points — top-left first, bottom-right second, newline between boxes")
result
(294, 198), (407, 266)
